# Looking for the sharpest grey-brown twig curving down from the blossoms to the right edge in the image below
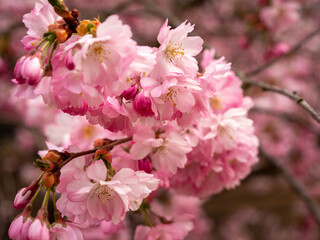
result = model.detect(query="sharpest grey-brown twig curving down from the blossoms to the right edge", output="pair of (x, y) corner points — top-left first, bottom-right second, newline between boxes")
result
(239, 75), (320, 123)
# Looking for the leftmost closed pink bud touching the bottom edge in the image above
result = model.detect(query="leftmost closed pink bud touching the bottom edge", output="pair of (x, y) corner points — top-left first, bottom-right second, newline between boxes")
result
(9, 214), (32, 240)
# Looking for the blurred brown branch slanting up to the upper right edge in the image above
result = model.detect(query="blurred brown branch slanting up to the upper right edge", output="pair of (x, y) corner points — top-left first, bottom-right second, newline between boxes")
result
(245, 28), (320, 77)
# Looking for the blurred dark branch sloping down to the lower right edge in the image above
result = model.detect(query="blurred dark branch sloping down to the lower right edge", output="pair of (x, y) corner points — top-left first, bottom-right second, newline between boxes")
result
(259, 147), (320, 227)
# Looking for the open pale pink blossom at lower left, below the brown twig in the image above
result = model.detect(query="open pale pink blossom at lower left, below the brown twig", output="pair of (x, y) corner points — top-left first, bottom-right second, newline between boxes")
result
(57, 161), (158, 224)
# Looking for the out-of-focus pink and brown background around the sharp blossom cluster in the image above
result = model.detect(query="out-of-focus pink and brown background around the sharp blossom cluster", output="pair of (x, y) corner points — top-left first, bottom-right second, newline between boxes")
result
(0, 0), (320, 240)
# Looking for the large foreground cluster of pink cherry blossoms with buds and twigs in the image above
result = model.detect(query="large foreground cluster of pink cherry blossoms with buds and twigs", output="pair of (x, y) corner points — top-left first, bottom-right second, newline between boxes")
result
(9, 0), (258, 240)
